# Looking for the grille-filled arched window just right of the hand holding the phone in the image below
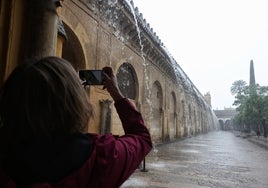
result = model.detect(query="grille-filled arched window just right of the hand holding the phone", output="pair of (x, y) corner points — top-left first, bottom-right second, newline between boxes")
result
(116, 63), (138, 100)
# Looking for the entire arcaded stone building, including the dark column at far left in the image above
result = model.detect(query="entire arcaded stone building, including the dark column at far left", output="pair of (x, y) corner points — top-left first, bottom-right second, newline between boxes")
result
(0, 0), (218, 143)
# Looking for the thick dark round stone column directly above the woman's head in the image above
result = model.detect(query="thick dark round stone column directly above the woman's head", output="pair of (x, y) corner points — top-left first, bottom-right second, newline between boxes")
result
(21, 0), (59, 58)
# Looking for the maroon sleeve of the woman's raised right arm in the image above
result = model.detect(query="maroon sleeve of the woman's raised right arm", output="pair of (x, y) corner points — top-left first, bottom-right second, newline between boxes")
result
(94, 99), (152, 187)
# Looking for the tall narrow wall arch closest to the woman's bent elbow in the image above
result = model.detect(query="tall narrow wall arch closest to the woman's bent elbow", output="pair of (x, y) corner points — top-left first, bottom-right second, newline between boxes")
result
(150, 81), (164, 142)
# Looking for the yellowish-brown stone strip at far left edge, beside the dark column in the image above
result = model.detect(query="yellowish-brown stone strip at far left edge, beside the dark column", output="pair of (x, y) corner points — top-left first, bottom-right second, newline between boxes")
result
(0, 0), (24, 84)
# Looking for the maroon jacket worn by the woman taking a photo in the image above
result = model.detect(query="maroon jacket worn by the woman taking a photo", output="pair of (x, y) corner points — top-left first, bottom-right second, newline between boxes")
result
(0, 99), (152, 188)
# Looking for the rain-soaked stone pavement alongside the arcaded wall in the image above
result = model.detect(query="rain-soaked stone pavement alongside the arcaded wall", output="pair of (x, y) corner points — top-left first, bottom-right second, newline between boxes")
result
(121, 131), (268, 188)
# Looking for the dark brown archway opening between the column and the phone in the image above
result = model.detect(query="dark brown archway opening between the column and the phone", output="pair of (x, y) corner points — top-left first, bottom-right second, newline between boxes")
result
(62, 23), (86, 70)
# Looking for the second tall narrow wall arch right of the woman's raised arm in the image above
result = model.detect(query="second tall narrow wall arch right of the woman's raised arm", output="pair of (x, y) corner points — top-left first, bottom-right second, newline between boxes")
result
(168, 92), (177, 139)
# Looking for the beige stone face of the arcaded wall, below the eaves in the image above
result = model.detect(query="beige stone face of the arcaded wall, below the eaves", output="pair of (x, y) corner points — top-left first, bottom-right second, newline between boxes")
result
(56, 0), (218, 142)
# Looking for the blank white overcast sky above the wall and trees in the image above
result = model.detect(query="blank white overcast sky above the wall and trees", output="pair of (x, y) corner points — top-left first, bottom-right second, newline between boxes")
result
(133, 0), (268, 109)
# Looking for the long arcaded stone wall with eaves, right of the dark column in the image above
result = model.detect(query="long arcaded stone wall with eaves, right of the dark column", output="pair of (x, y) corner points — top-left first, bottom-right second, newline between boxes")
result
(59, 0), (220, 142)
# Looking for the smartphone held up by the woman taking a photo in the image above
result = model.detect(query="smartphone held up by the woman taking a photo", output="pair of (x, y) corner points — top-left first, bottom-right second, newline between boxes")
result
(78, 70), (103, 85)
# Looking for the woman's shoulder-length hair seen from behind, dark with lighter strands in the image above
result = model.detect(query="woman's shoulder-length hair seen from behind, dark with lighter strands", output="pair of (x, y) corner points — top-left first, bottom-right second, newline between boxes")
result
(0, 57), (92, 144)
